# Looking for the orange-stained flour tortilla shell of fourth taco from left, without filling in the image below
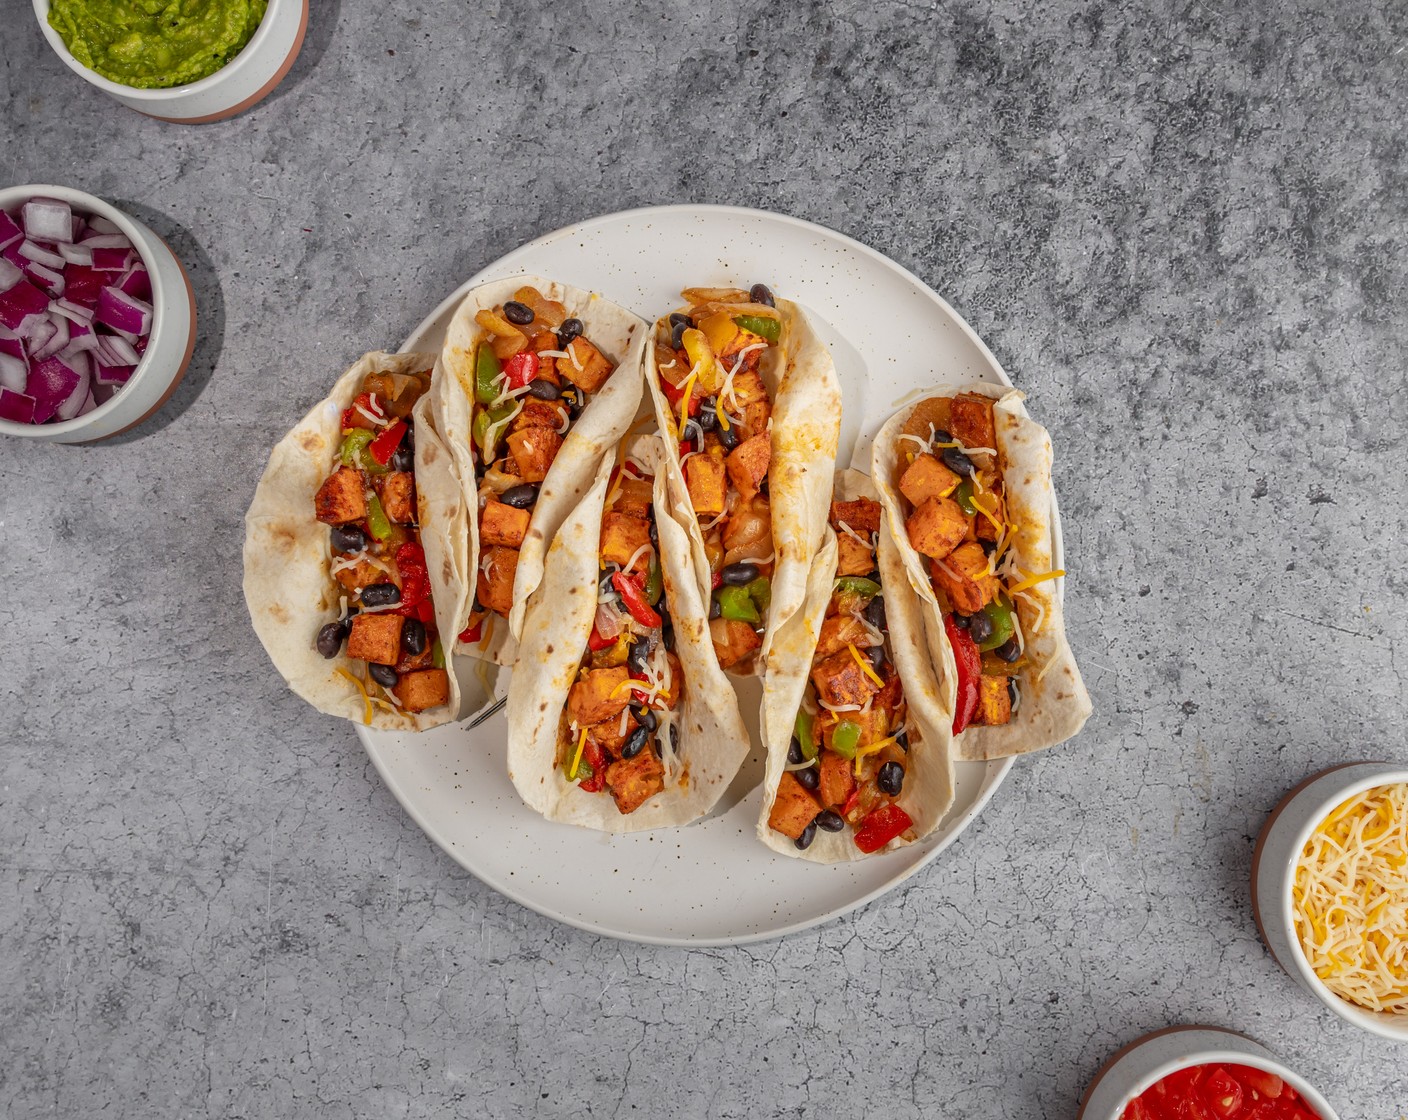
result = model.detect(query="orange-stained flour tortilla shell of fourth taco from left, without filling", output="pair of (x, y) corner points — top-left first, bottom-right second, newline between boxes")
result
(645, 293), (841, 672)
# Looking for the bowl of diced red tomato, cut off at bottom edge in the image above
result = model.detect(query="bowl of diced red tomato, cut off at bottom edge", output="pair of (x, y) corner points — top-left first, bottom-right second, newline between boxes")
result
(1077, 1027), (1339, 1120)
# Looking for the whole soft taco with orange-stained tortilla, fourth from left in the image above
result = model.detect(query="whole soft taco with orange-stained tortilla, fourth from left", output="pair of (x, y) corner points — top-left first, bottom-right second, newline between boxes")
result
(646, 285), (841, 673)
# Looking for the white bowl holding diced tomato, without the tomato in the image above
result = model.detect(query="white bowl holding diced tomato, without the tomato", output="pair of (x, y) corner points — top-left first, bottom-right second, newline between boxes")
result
(1076, 1027), (1339, 1120)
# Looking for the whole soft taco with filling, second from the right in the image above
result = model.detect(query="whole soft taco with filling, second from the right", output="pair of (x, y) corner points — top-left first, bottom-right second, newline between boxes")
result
(758, 471), (953, 864)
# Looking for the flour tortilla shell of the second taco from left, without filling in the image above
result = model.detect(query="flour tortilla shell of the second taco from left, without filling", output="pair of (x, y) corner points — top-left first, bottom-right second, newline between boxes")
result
(434, 276), (649, 665)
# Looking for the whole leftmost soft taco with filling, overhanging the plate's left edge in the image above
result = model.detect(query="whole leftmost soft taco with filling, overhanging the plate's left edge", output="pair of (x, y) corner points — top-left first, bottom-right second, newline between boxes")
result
(244, 354), (466, 731)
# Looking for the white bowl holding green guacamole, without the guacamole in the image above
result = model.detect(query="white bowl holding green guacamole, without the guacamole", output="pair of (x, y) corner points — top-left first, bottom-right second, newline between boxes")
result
(32, 0), (308, 124)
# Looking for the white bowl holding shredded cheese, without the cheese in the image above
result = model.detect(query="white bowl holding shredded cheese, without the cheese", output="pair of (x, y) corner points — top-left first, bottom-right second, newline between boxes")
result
(1252, 762), (1408, 1043)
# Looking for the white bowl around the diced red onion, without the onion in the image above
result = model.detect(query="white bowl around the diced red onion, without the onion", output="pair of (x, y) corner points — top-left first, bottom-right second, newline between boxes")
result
(0, 185), (196, 444)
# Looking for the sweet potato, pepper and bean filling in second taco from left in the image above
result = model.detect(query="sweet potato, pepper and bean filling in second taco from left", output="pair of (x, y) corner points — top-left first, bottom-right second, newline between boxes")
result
(459, 287), (615, 642)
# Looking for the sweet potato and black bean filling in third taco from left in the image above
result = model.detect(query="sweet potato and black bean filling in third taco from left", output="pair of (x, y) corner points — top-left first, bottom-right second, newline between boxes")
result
(556, 458), (684, 813)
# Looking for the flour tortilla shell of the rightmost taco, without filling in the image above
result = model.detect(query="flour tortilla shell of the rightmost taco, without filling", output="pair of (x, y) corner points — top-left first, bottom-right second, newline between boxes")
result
(872, 382), (1091, 759)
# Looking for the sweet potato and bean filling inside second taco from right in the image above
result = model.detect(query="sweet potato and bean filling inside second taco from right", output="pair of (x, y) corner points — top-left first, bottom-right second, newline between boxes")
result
(767, 497), (914, 852)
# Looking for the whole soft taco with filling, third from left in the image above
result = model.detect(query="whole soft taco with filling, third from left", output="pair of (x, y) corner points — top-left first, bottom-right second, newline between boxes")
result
(508, 438), (749, 833)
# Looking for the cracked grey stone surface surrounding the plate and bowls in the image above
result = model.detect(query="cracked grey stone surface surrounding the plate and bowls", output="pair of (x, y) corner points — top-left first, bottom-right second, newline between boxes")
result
(0, 0), (1408, 1120)
